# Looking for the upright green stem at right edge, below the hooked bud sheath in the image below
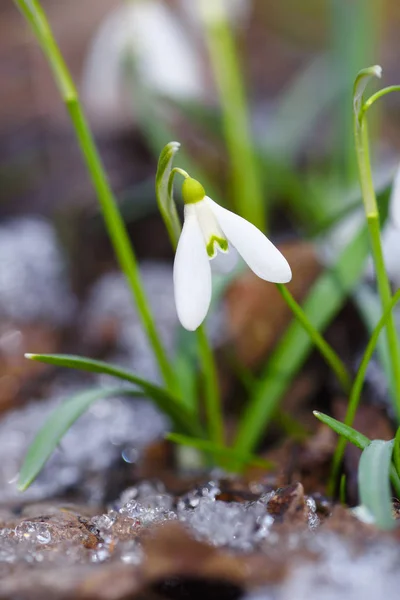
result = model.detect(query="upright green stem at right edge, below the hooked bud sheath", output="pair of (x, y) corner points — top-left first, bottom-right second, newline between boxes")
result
(354, 113), (400, 419)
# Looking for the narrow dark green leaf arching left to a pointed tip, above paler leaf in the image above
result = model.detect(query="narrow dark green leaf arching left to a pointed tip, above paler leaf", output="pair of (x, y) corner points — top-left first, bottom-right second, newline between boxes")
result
(25, 354), (202, 437)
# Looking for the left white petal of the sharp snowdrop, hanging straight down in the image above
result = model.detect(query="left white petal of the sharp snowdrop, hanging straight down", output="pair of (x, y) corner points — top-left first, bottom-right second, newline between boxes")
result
(174, 206), (211, 331)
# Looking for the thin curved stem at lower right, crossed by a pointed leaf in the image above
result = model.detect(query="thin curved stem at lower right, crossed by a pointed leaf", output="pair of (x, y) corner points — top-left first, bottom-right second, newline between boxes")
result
(327, 290), (400, 496)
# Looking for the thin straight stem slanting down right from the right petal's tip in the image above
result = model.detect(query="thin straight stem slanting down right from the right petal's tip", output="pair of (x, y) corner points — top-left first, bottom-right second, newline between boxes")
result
(276, 283), (352, 392)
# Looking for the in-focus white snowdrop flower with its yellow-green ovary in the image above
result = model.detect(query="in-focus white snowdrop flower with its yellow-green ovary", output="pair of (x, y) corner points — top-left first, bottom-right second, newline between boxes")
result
(174, 177), (292, 331)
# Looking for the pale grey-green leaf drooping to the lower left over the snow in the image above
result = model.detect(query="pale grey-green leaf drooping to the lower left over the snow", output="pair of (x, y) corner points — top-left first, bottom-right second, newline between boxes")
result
(18, 387), (142, 491)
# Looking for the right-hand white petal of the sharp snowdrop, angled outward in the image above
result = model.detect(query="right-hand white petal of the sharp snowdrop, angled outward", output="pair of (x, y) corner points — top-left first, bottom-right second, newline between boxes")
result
(206, 197), (292, 283)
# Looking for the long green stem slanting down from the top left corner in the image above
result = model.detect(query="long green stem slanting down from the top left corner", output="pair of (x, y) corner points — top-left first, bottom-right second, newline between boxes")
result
(14, 0), (175, 389)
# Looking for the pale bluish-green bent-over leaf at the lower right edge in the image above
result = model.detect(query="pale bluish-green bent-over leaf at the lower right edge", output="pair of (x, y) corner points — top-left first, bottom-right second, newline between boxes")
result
(358, 440), (396, 530)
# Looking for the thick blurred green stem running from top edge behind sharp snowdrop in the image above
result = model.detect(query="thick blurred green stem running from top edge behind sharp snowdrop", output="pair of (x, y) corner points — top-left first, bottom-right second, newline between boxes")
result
(197, 0), (267, 230)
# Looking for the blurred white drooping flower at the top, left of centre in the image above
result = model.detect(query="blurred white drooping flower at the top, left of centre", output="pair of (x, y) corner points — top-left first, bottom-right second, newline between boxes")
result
(82, 0), (205, 126)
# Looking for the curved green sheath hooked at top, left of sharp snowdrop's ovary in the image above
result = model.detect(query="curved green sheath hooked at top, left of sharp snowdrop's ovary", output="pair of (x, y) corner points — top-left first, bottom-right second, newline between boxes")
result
(156, 142), (181, 248)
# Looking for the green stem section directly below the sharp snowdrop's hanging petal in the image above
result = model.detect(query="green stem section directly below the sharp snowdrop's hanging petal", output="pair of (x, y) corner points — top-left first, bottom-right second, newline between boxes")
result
(197, 325), (224, 446)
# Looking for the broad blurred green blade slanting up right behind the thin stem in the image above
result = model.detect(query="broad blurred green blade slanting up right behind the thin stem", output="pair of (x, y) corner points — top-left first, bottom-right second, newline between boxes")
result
(235, 223), (368, 452)
